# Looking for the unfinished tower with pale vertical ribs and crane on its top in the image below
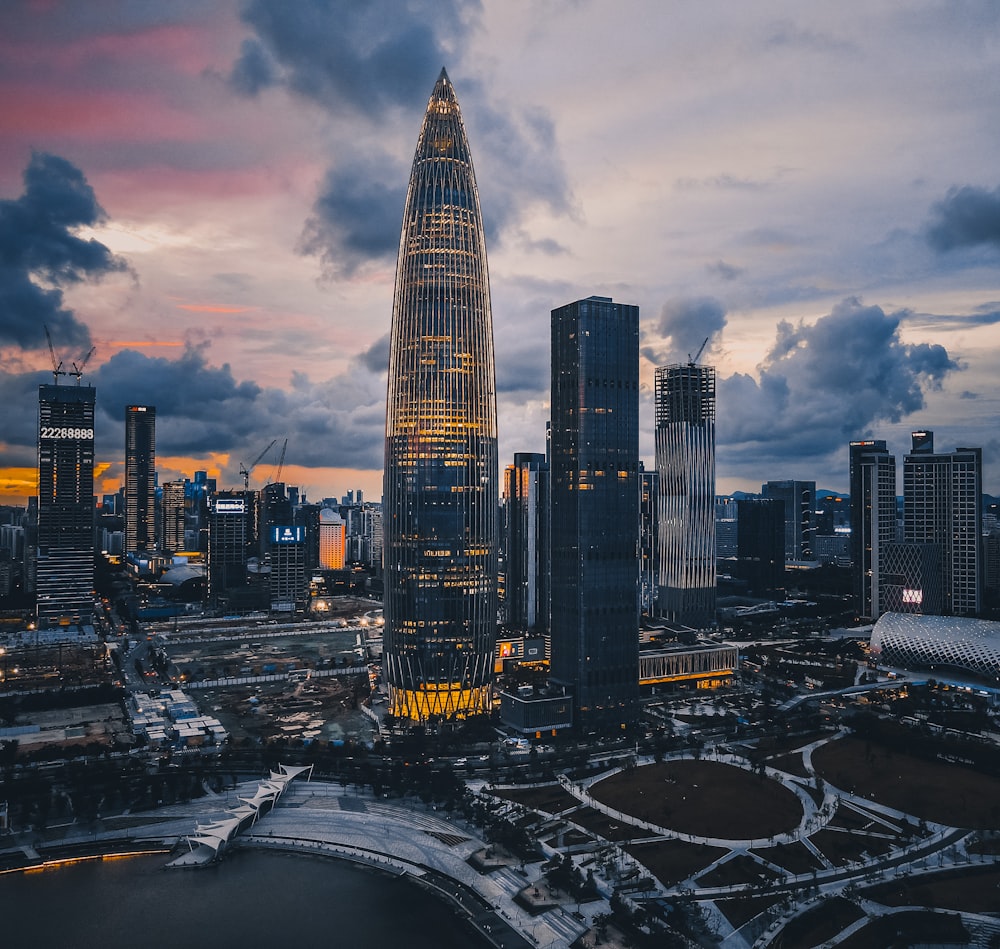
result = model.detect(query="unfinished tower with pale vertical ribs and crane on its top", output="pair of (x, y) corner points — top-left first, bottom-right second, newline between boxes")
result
(656, 362), (715, 629)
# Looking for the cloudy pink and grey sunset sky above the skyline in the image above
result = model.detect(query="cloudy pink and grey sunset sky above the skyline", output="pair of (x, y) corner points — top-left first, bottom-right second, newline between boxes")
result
(0, 0), (1000, 499)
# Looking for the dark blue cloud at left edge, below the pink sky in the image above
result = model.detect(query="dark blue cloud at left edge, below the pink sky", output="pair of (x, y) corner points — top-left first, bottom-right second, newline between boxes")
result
(0, 152), (127, 350)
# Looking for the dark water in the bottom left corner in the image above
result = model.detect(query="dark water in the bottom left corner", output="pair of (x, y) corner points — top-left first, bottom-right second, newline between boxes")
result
(0, 850), (487, 949)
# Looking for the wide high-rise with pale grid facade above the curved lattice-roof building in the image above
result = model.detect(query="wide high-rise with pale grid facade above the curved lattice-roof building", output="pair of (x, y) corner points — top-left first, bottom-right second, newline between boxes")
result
(903, 431), (983, 616)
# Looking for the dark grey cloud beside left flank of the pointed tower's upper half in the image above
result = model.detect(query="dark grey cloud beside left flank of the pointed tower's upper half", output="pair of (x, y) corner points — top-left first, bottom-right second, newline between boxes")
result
(299, 152), (407, 275)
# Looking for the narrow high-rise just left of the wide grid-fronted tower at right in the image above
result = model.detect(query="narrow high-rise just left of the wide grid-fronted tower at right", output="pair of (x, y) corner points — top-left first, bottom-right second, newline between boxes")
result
(850, 439), (896, 619)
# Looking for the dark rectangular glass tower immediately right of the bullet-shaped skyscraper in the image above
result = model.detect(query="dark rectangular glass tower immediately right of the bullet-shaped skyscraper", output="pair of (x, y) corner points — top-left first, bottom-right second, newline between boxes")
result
(549, 297), (639, 733)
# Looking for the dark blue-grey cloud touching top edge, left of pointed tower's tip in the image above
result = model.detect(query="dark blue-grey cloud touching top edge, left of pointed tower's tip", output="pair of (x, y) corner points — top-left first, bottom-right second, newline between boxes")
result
(231, 0), (478, 118)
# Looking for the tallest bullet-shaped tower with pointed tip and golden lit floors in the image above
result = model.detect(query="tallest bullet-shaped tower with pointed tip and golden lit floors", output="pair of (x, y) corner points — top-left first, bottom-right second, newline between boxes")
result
(383, 70), (499, 721)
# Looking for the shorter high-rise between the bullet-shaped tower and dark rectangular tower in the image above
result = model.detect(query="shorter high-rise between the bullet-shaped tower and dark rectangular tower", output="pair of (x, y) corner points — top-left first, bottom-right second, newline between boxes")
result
(504, 452), (549, 633)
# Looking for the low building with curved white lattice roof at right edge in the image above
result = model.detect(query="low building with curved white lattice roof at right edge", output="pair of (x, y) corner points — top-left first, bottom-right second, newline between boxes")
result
(871, 613), (1000, 683)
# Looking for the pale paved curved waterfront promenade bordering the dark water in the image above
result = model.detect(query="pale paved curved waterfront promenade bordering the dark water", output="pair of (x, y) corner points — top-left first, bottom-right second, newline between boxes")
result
(0, 781), (588, 949)
